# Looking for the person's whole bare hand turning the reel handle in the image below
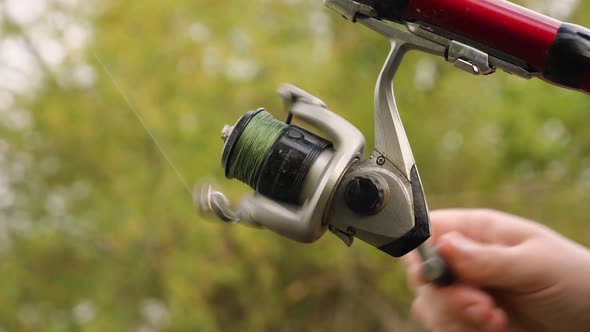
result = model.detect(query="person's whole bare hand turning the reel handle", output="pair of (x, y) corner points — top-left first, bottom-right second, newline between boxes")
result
(404, 210), (590, 332)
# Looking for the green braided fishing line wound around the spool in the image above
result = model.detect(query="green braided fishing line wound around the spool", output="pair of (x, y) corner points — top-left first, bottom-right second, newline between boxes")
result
(228, 111), (288, 189)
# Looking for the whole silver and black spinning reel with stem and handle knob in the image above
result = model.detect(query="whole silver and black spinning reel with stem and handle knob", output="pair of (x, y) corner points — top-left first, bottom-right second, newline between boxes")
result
(194, 7), (453, 285)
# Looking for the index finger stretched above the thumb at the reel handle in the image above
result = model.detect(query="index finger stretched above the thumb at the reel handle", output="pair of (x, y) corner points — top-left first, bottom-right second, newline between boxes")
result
(430, 209), (543, 245)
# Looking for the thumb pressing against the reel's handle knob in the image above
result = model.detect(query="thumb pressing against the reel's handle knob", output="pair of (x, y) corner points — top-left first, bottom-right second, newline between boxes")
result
(438, 232), (520, 288)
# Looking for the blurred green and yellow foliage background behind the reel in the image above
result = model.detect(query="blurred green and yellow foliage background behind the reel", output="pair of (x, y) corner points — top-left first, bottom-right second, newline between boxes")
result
(0, 0), (590, 332)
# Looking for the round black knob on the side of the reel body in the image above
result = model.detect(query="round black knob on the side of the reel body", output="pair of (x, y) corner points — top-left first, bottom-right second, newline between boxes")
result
(344, 175), (385, 216)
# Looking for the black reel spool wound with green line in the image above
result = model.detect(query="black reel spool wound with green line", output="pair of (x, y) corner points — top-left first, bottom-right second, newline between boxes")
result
(221, 108), (333, 205)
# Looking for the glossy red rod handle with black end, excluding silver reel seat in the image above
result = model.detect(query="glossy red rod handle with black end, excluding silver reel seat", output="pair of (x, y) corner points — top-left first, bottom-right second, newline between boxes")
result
(361, 0), (590, 93)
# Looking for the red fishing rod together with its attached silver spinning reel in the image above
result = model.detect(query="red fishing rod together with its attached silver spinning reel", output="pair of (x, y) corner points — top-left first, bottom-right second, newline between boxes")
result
(198, 0), (590, 286)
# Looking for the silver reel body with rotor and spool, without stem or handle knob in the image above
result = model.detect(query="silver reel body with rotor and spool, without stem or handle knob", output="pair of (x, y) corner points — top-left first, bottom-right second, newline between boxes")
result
(213, 85), (430, 257)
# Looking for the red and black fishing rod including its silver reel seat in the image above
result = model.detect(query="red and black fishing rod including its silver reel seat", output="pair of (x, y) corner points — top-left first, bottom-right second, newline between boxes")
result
(350, 0), (590, 93)
